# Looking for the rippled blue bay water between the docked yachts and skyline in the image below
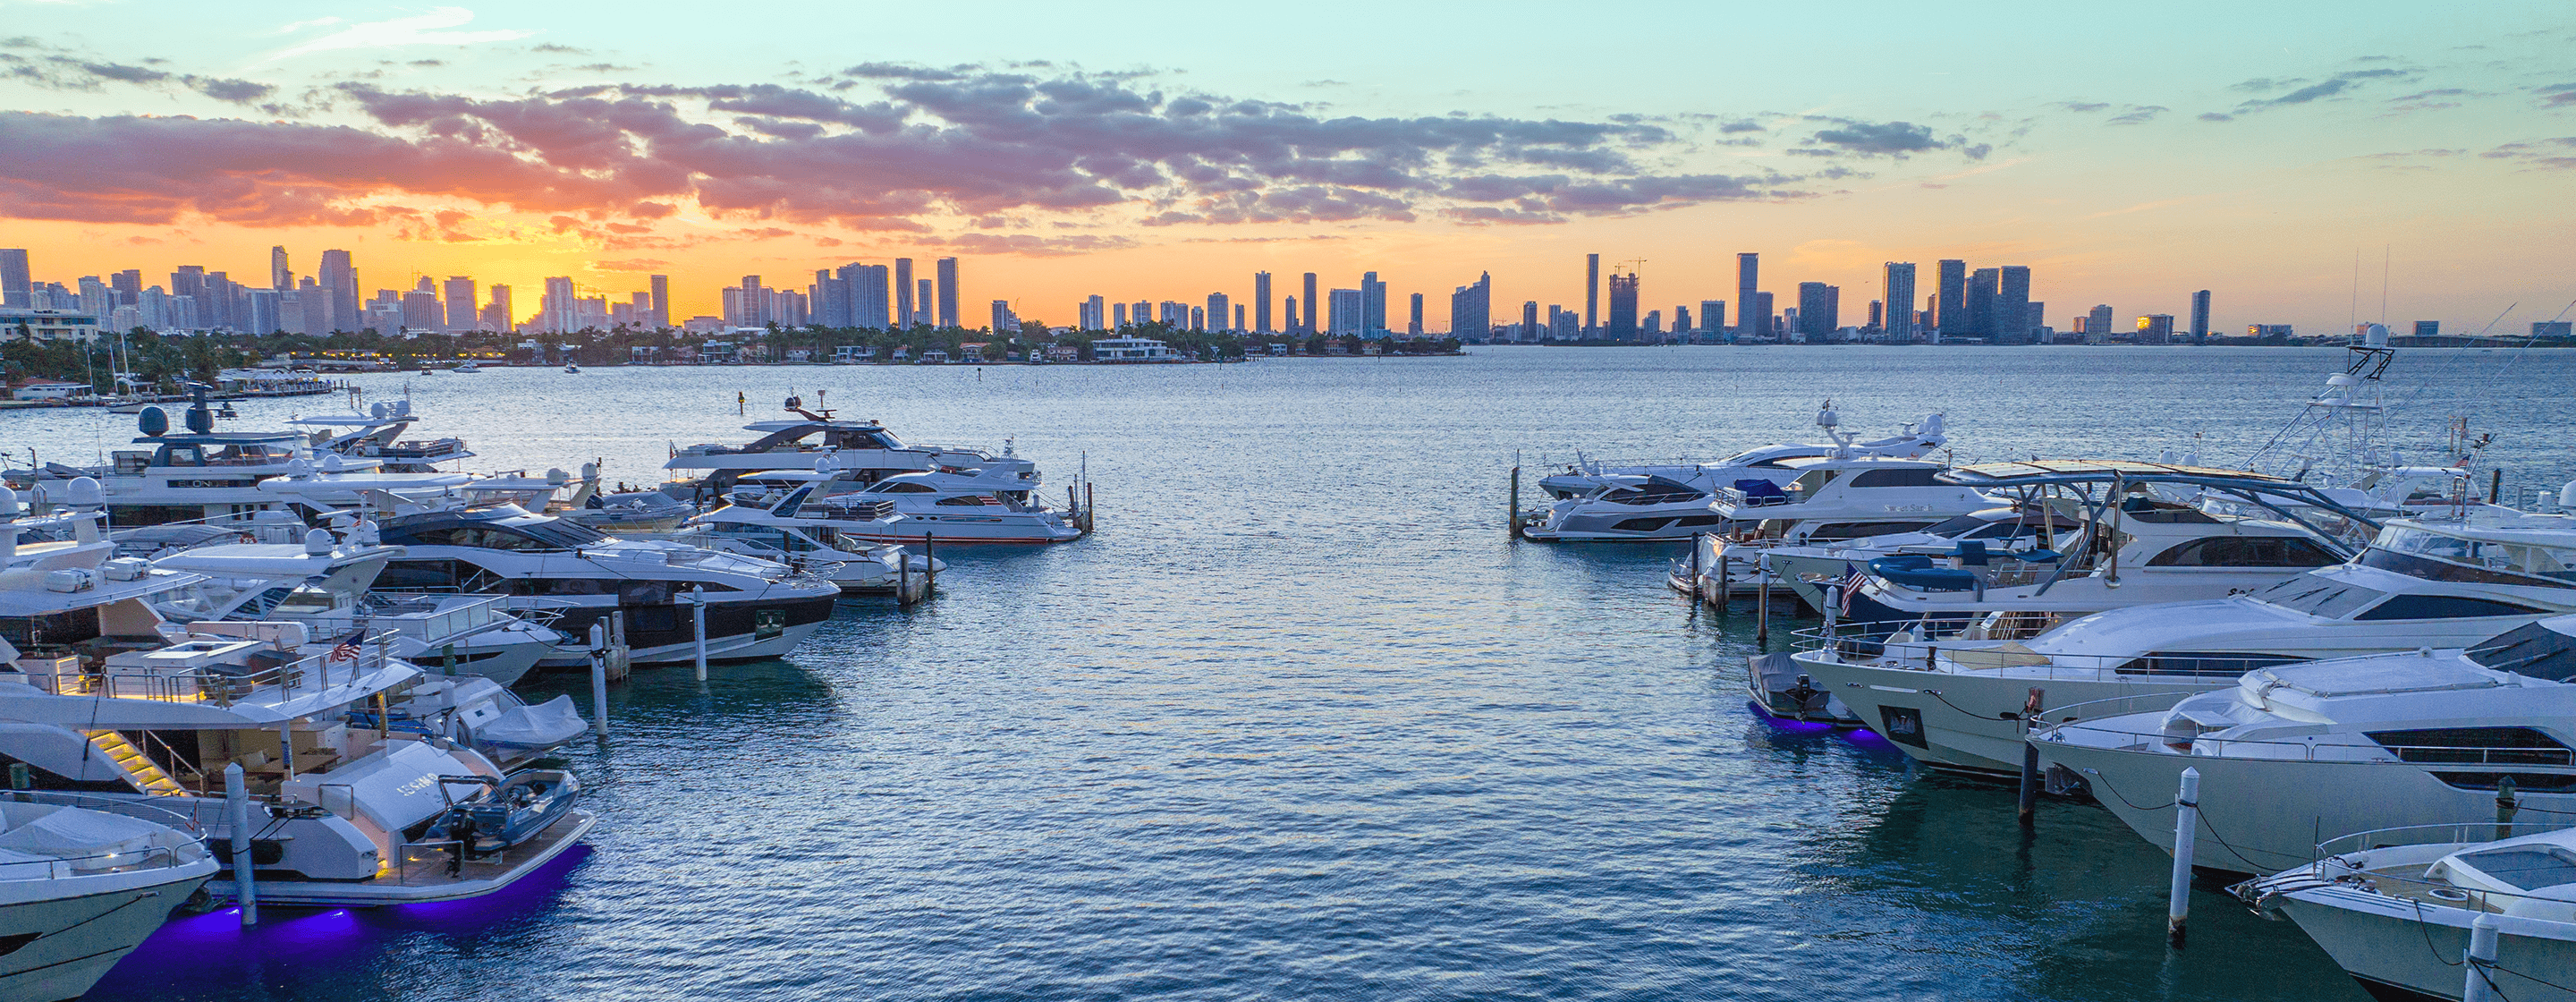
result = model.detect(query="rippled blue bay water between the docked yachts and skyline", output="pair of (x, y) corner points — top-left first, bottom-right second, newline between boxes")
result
(14, 348), (2576, 1002)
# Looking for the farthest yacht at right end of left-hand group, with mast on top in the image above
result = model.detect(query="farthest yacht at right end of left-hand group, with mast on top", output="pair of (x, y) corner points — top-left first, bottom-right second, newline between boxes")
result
(662, 396), (1038, 500)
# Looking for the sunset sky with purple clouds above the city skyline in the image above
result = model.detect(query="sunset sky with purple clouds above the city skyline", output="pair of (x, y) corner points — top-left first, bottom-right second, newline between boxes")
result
(0, 0), (2576, 335)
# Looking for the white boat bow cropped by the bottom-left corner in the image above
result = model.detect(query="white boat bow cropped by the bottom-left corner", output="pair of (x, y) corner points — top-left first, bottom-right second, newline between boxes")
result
(0, 794), (216, 1002)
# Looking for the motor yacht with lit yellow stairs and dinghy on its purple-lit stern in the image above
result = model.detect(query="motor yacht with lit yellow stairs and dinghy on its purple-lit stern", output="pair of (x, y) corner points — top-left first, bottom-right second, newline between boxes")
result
(0, 633), (595, 906)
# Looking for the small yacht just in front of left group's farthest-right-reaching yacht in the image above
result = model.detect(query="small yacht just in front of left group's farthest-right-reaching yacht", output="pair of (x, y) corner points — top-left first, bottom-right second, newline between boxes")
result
(691, 489), (948, 600)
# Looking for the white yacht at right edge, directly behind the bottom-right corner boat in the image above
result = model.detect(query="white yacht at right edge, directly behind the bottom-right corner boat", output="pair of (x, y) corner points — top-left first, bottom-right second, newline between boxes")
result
(2029, 616), (2576, 873)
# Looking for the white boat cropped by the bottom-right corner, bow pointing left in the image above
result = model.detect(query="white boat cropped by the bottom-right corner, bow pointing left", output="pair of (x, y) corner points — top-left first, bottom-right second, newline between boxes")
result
(2233, 821), (2576, 999)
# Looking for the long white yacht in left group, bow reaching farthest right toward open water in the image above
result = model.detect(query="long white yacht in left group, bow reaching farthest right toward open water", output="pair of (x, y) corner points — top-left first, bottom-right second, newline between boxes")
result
(734, 458), (1087, 544)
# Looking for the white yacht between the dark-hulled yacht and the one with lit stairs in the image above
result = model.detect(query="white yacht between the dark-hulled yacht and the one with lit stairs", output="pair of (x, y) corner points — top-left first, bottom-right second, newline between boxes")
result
(152, 525), (569, 685)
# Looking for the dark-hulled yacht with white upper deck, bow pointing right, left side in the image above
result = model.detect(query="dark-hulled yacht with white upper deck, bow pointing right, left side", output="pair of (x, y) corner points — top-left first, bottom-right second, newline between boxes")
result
(263, 474), (840, 667)
